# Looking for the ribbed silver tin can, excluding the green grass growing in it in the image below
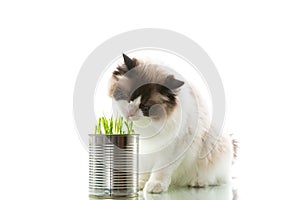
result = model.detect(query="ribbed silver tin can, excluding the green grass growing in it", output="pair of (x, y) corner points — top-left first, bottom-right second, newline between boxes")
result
(89, 134), (139, 198)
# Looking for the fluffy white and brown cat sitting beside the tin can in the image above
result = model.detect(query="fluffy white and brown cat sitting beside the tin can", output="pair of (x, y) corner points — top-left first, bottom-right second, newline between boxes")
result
(109, 54), (237, 193)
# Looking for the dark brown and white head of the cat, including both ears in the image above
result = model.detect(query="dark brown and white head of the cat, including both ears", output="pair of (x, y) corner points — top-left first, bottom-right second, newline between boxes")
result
(110, 55), (184, 120)
